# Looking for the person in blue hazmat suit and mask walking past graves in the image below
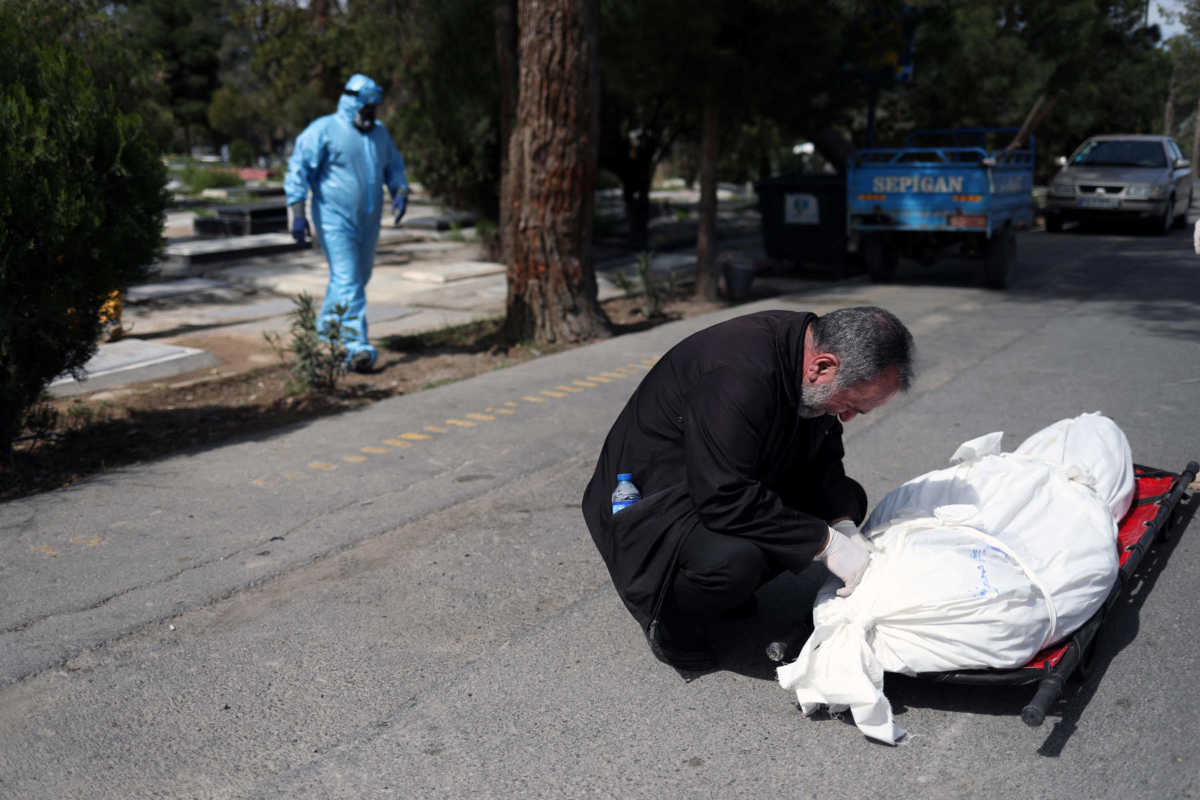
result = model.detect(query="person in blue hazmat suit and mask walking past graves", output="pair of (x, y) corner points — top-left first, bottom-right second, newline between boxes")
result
(283, 74), (408, 372)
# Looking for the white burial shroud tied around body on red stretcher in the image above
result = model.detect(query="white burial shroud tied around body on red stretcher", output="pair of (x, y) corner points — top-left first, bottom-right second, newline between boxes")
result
(778, 414), (1134, 744)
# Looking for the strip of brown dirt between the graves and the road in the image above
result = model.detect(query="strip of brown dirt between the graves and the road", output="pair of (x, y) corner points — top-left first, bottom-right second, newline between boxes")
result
(0, 287), (726, 501)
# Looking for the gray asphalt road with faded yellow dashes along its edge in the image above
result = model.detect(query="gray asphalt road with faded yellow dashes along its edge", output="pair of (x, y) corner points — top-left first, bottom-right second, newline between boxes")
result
(0, 221), (1200, 799)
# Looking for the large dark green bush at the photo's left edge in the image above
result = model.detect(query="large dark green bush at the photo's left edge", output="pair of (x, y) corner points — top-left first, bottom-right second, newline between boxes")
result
(0, 2), (167, 453)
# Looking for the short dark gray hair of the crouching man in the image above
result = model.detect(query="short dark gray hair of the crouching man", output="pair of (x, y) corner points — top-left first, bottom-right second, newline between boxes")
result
(812, 306), (916, 391)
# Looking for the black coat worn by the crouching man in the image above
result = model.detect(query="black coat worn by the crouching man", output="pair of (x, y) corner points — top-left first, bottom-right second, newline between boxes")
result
(583, 311), (866, 628)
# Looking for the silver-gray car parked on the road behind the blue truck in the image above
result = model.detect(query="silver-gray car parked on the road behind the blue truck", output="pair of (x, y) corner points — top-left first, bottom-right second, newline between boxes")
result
(1043, 134), (1192, 234)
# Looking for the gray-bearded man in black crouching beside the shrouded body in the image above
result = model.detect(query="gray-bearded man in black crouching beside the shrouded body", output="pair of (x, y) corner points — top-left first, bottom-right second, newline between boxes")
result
(583, 307), (913, 670)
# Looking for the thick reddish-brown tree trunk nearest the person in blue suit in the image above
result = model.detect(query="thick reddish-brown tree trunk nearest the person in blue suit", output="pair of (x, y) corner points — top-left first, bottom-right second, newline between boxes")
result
(504, 0), (608, 344)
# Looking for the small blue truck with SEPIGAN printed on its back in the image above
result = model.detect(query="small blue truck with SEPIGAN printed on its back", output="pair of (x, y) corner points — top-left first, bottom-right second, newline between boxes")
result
(846, 128), (1034, 289)
